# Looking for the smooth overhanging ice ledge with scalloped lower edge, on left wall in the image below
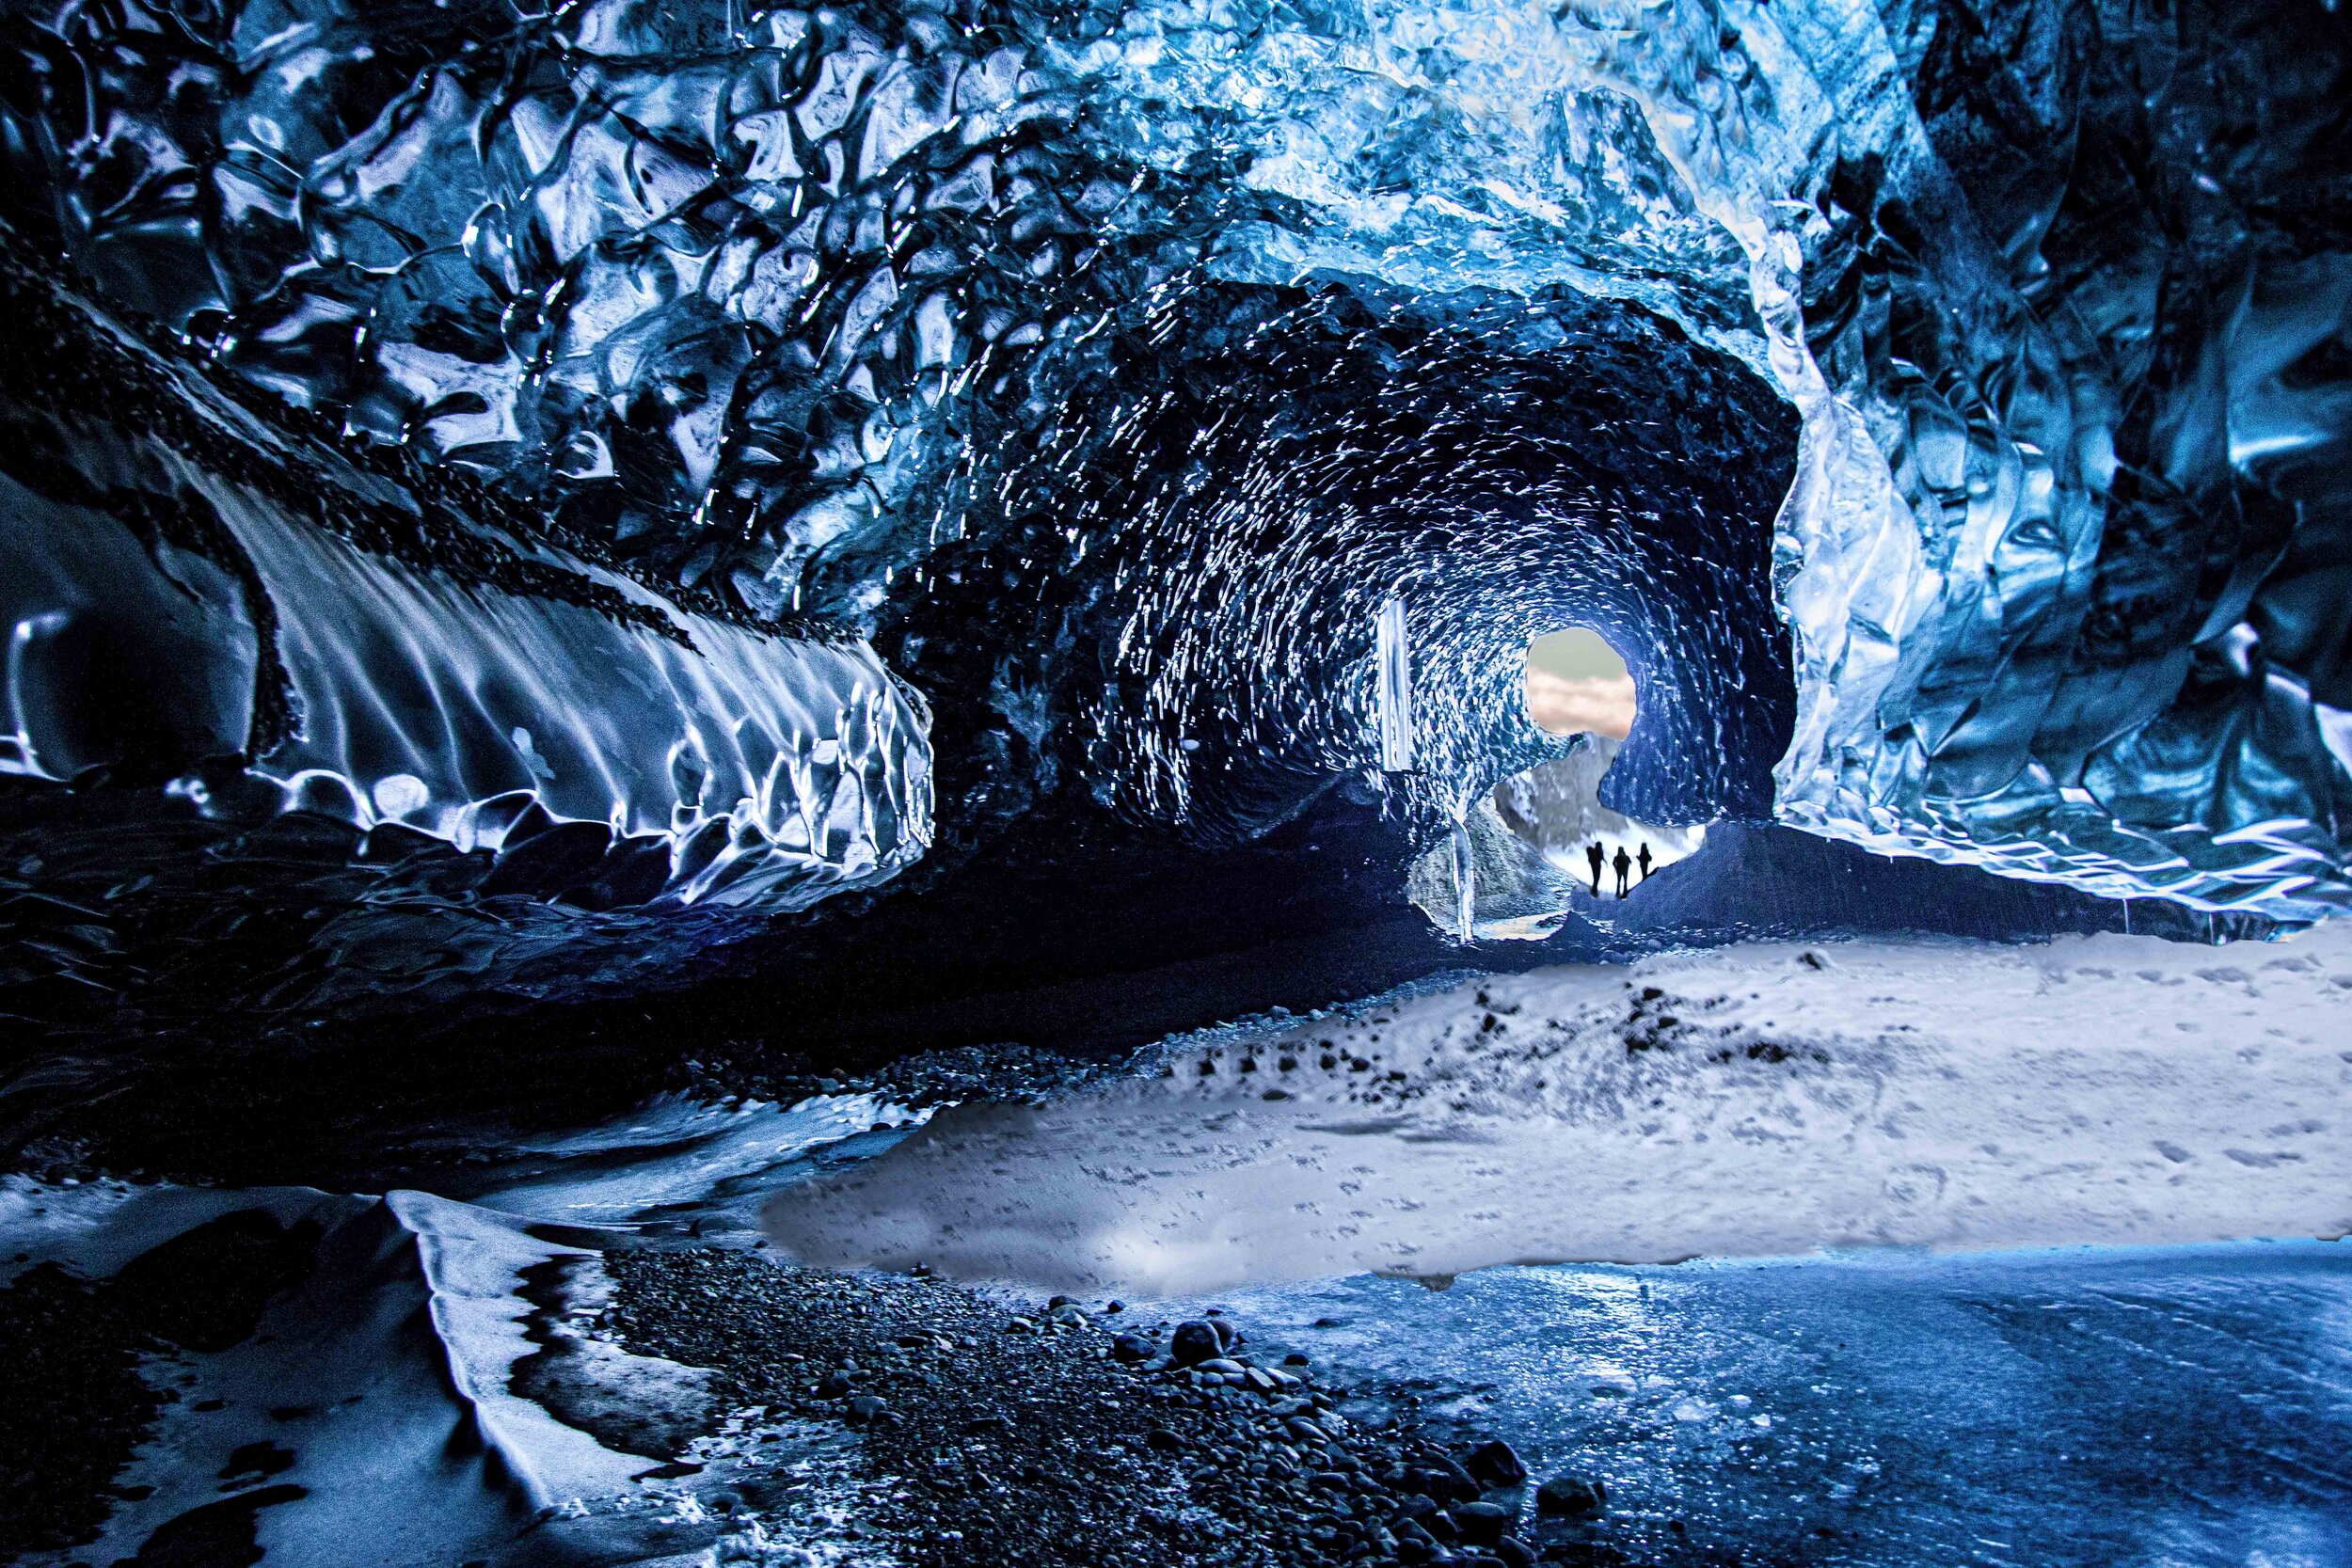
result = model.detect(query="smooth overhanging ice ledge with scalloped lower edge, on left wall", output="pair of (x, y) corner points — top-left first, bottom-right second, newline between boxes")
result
(0, 236), (930, 908)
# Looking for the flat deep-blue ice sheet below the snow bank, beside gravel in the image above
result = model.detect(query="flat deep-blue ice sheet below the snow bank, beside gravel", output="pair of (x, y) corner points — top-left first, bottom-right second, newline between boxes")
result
(1155, 1242), (2352, 1568)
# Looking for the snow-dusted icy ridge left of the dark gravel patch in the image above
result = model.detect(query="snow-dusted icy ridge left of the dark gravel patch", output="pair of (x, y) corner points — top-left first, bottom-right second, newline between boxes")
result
(0, 1093), (922, 1568)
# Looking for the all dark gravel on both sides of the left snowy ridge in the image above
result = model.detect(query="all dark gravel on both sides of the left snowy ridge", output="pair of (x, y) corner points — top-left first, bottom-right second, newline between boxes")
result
(0, 1189), (1628, 1568)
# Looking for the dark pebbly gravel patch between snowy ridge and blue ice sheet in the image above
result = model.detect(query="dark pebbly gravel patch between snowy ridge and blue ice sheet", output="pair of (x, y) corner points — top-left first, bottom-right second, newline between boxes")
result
(605, 1251), (1626, 1568)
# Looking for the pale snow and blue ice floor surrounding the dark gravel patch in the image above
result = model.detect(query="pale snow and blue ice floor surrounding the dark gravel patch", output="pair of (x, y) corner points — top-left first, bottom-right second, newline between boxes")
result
(0, 933), (2352, 1568)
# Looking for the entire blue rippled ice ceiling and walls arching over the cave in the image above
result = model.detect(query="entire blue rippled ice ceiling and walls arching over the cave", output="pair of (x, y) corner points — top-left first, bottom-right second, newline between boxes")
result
(0, 0), (2352, 1053)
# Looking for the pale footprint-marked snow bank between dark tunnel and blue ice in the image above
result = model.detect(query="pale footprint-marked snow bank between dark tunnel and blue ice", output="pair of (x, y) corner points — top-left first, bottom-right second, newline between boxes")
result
(767, 928), (2352, 1295)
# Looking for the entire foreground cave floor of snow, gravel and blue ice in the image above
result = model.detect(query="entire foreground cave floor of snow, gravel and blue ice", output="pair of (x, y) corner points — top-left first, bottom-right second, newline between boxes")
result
(0, 938), (2352, 1568)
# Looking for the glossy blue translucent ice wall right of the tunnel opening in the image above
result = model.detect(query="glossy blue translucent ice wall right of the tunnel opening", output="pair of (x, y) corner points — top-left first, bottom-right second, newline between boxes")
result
(1604, 5), (2352, 917)
